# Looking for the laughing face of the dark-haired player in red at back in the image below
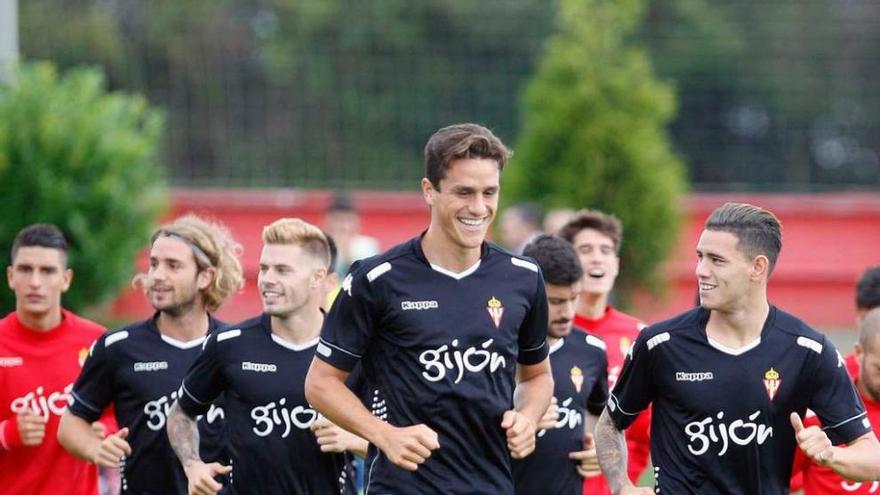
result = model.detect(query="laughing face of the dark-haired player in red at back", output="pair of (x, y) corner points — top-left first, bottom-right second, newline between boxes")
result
(572, 229), (620, 295)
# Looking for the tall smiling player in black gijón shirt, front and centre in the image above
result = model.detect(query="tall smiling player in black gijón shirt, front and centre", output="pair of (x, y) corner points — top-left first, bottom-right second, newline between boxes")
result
(306, 124), (553, 495)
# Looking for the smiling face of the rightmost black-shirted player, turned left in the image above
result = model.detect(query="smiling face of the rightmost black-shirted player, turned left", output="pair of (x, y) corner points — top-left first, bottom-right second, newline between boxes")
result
(696, 230), (753, 311)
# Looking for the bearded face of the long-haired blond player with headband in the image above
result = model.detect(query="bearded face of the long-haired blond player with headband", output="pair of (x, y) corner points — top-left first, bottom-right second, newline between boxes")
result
(147, 237), (208, 316)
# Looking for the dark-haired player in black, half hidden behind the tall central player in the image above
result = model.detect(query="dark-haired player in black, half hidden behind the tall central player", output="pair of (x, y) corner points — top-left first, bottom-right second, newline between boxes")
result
(513, 235), (608, 495)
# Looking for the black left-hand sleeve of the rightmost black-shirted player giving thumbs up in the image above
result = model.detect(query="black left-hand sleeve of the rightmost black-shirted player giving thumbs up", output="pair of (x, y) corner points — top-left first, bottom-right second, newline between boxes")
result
(608, 331), (652, 430)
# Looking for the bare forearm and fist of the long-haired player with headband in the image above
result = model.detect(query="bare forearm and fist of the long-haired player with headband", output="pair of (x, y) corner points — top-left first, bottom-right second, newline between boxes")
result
(58, 410), (131, 468)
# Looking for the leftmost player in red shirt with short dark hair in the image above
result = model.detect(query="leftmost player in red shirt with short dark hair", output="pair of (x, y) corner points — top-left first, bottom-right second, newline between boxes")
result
(0, 224), (104, 495)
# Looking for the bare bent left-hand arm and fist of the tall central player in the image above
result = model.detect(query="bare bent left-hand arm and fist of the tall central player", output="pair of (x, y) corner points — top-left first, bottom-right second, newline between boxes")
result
(306, 357), (440, 471)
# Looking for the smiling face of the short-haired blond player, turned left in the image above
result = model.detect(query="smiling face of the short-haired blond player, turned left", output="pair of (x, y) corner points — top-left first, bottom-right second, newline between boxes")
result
(257, 244), (324, 318)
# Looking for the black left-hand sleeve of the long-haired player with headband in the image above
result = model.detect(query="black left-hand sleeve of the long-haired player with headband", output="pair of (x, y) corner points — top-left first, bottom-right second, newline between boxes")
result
(68, 333), (115, 423)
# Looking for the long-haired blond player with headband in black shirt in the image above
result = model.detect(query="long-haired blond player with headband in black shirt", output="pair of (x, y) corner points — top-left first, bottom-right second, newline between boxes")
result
(58, 215), (244, 494)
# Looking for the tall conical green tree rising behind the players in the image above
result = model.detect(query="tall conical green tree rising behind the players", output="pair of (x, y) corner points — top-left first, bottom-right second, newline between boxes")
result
(503, 0), (686, 303)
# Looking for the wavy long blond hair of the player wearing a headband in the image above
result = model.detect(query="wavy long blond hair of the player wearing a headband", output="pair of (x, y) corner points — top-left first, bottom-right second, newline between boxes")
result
(134, 213), (244, 312)
